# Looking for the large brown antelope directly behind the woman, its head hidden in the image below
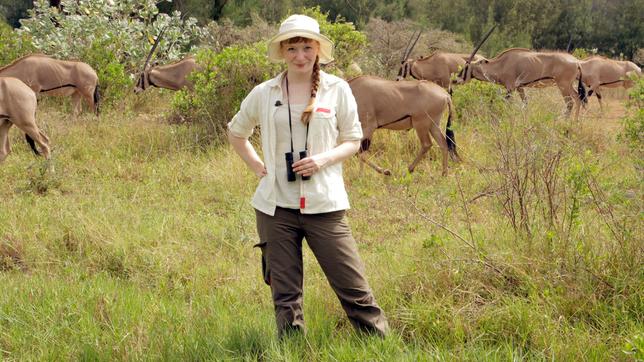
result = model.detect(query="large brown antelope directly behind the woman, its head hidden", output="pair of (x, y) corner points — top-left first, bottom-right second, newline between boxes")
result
(349, 76), (458, 175)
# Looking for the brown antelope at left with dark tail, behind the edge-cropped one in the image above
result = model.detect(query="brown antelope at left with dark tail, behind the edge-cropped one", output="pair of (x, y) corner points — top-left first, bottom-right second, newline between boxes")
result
(0, 54), (100, 115)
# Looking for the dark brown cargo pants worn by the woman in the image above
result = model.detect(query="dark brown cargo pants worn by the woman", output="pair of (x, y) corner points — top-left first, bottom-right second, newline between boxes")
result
(255, 207), (389, 336)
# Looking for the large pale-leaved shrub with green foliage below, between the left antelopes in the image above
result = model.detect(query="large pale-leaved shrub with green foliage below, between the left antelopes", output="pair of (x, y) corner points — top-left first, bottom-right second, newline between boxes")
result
(18, 0), (200, 107)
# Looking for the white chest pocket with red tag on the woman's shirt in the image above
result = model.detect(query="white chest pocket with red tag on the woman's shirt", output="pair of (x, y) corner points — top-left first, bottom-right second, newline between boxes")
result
(309, 104), (339, 155)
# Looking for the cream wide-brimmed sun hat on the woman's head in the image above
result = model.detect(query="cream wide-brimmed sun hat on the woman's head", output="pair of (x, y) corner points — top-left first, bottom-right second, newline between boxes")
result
(268, 15), (333, 64)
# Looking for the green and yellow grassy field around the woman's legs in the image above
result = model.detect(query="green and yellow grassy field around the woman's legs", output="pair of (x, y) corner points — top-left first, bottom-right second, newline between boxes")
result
(0, 90), (644, 361)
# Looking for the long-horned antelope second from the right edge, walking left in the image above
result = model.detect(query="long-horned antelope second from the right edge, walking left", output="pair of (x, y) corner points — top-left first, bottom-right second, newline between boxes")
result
(460, 48), (585, 119)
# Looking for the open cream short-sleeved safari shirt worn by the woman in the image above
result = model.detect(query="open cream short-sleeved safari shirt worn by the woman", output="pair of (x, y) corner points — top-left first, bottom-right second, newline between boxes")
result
(228, 71), (362, 216)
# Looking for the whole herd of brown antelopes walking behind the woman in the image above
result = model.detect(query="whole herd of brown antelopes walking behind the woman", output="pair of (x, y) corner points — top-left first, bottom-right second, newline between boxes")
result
(0, 28), (641, 175)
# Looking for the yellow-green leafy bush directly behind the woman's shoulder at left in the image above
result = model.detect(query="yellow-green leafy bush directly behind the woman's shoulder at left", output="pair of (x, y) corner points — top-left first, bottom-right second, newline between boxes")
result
(172, 42), (282, 144)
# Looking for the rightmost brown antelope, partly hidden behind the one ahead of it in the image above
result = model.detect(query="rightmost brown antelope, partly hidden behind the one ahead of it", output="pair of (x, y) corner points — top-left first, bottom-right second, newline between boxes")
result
(580, 56), (642, 111)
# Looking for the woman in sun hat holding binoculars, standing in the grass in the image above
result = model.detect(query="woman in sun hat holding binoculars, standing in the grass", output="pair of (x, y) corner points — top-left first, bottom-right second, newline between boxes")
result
(228, 15), (388, 337)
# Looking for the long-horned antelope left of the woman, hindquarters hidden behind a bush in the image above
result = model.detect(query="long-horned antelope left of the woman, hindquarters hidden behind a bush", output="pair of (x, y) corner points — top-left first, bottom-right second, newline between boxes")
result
(134, 28), (197, 93)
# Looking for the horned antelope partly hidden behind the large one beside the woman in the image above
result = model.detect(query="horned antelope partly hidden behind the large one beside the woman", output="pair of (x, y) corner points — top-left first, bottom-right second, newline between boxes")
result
(396, 34), (484, 90)
